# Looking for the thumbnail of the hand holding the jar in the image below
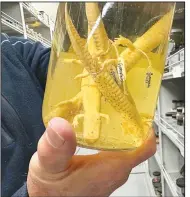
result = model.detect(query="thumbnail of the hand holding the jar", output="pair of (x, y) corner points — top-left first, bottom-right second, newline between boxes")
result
(46, 124), (65, 148)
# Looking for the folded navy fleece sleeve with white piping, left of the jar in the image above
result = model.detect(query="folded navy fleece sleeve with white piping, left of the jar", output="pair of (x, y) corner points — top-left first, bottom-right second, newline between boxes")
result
(9, 37), (50, 89)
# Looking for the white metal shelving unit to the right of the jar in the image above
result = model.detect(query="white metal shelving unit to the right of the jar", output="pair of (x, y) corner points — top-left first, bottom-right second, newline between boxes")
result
(148, 3), (185, 197)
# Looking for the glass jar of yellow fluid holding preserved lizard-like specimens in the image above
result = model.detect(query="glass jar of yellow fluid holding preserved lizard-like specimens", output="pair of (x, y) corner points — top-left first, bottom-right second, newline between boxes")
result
(43, 2), (175, 150)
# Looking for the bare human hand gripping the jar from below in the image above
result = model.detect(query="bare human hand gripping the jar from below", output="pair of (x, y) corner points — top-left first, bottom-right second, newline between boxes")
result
(27, 118), (156, 197)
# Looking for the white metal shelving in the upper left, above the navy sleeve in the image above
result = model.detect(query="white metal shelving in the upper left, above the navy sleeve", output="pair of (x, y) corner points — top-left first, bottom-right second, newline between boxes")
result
(1, 2), (54, 47)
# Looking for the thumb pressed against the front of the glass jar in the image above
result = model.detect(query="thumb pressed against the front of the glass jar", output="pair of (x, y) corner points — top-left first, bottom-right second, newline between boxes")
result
(37, 117), (76, 173)
